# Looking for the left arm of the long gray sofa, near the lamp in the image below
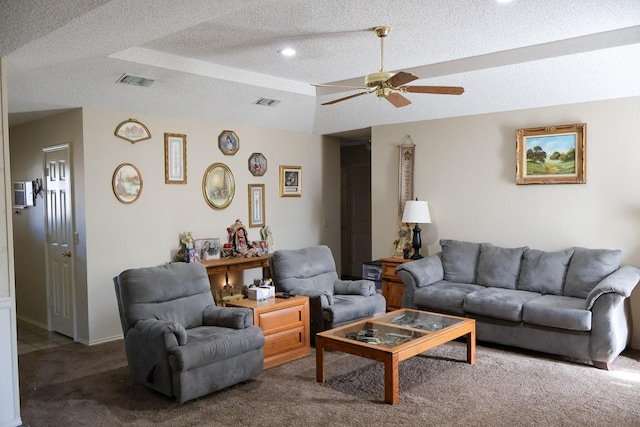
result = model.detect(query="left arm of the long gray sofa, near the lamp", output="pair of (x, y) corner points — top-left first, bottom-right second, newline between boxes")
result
(396, 253), (444, 308)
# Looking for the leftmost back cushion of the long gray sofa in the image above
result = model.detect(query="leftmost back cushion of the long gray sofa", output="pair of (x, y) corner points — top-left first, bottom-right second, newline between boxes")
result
(440, 239), (480, 283)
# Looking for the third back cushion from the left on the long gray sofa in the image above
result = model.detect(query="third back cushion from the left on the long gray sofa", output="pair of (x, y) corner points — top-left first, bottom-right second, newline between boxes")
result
(518, 249), (573, 295)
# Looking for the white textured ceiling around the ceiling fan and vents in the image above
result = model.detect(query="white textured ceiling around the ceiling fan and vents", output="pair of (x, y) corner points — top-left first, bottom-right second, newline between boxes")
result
(0, 0), (640, 134)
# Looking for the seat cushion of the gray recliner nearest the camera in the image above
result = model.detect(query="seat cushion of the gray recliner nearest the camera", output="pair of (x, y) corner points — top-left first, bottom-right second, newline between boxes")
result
(169, 326), (264, 372)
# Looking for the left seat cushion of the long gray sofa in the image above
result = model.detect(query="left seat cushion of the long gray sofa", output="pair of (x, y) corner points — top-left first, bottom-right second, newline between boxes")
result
(413, 280), (484, 315)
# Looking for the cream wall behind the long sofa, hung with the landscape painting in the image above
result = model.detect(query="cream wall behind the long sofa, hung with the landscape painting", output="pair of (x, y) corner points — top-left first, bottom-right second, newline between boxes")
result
(372, 97), (640, 347)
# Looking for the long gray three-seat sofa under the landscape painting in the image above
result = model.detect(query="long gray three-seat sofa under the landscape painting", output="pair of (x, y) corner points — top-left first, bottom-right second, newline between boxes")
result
(397, 240), (640, 369)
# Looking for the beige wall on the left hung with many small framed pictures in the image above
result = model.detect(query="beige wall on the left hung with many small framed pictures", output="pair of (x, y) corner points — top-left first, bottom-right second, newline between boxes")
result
(11, 108), (340, 343)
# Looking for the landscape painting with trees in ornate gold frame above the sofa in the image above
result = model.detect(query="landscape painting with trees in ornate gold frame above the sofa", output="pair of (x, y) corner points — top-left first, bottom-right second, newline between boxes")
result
(516, 123), (587, 185)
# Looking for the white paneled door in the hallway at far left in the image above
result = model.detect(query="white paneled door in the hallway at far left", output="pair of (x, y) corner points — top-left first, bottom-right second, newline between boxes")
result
(44, 145), (75, 338)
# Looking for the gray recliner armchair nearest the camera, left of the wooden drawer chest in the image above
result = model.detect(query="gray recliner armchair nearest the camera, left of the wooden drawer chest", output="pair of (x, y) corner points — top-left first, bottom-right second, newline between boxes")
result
(113, 263), (264, 403)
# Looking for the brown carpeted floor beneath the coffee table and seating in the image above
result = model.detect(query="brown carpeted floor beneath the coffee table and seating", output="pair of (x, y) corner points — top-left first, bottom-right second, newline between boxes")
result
(19, 341), (640, 427)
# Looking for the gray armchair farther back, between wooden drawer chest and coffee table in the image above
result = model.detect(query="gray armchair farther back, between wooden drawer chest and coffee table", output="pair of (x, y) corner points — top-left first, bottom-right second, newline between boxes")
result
(269, 246), (386, 339)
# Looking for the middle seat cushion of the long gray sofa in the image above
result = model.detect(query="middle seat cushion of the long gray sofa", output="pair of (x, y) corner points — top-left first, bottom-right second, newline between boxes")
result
(464, 288), (542, 322)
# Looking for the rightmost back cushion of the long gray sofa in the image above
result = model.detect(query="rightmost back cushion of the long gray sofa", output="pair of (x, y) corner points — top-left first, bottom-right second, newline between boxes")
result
(564, 248), (622, 298)
